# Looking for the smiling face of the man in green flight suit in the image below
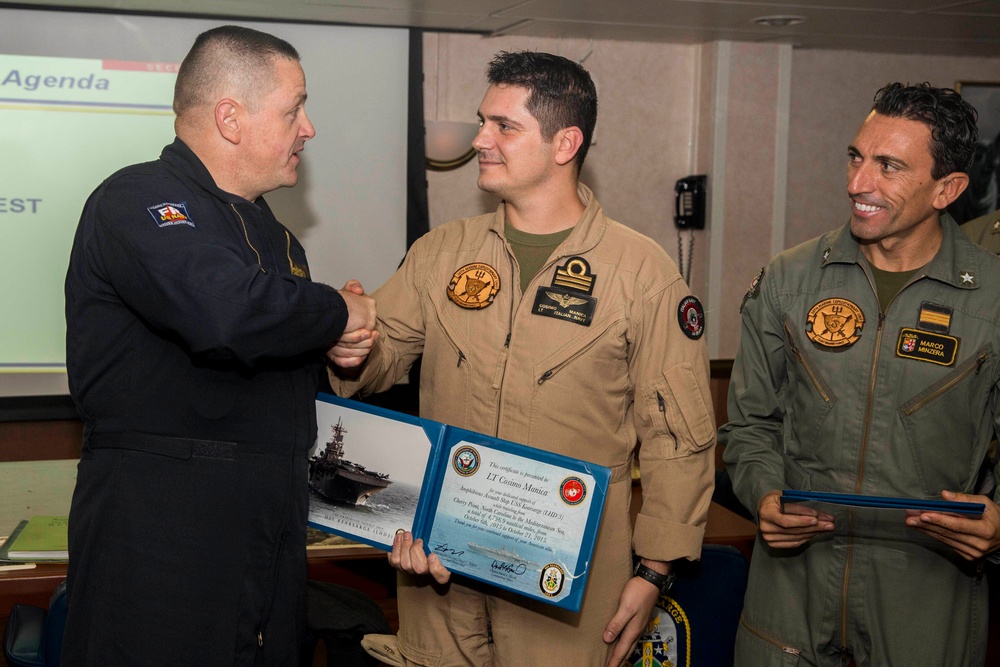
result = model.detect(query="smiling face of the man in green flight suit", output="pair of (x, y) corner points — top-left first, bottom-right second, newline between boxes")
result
(847, 112), (951, 250)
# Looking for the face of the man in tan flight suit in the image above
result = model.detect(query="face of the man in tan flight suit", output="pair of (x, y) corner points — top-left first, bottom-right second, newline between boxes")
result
(472, 84), (556, 201)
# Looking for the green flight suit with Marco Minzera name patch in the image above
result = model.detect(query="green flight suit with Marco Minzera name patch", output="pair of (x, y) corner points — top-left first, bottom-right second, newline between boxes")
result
(720, 219), (1000, 667)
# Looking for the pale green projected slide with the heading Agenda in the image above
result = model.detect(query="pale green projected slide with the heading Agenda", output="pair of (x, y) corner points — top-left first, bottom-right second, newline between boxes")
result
(0, 54), (178, 372)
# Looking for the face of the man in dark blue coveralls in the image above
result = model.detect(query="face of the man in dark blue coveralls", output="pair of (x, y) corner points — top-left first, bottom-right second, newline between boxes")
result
(240, 58), (316, 201)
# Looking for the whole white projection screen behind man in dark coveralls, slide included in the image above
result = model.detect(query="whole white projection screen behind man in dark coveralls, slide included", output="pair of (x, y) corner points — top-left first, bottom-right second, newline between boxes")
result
(0, 7), (409, 399)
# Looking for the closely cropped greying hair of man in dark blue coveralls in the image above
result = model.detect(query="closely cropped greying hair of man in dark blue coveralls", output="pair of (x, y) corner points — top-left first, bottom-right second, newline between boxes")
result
(174, 25), (299, 116)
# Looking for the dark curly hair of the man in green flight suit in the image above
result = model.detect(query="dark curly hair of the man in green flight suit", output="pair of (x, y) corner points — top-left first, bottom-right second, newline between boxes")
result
(872, 82), (979, 180)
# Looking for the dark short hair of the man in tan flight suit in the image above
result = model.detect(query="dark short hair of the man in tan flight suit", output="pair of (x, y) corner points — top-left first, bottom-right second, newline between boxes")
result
(486, 51), (597, 170)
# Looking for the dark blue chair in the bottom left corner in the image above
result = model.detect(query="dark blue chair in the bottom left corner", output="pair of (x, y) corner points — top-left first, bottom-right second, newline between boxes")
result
(3, 581), (66, 667)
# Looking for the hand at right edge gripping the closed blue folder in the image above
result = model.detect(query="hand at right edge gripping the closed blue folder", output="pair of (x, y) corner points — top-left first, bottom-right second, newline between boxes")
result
(906, 491), (1000, 561)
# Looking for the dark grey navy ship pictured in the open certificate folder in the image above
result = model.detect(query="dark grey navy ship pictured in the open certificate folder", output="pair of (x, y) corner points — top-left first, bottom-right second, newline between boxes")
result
(309, 417), (392, 505)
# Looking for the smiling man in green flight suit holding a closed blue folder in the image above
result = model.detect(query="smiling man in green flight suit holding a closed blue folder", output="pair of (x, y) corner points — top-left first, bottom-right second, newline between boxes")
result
(720, 83), (1000, 667)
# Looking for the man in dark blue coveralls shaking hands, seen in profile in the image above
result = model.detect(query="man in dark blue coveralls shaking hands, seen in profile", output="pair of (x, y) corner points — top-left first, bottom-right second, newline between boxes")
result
(63, 26), (375, 667)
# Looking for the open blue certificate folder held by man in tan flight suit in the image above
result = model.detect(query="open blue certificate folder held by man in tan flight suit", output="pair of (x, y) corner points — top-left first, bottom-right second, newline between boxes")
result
(309, 393), (611, 611)
